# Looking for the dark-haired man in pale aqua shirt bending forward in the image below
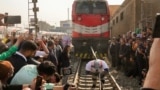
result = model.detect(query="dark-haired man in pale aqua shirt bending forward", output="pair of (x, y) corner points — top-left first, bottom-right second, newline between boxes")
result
(11, 61), (56, 85)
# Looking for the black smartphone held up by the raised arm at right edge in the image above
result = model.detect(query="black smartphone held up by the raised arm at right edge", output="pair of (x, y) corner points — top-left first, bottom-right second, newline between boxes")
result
(152, 15), (160, 38)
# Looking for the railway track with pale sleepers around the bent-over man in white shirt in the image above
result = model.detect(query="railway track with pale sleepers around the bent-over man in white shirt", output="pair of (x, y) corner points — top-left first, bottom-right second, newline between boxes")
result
(68, 58), (121, 90)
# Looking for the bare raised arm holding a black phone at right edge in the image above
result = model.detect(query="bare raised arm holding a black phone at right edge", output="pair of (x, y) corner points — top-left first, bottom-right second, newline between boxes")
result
(141, 15), (160, 90)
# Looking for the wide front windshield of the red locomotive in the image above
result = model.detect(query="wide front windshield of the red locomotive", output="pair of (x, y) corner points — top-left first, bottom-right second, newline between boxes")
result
(76, 1), (107, 14)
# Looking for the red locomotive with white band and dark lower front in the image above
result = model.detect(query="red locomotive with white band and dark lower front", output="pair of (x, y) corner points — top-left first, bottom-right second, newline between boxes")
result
(72, 0), (110, 59)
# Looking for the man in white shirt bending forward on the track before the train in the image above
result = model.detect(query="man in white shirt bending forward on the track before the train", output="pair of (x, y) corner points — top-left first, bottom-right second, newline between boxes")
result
(85, 59), (109, 88)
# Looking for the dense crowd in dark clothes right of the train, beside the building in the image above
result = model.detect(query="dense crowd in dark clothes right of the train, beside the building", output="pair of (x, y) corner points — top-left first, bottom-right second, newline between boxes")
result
(109, 28), (153, 85)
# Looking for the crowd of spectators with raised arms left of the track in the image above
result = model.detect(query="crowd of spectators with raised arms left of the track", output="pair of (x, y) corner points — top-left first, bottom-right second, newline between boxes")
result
(0, 34), (76, 90)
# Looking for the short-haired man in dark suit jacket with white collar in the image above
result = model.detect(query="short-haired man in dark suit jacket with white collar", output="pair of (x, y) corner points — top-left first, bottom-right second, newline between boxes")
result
(9, 41), (38, 82)
